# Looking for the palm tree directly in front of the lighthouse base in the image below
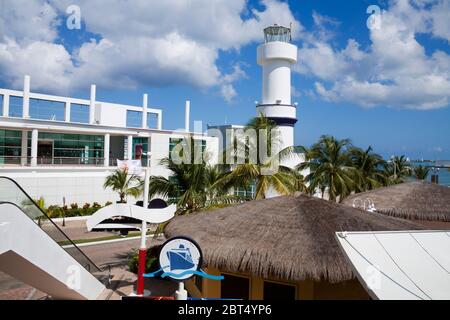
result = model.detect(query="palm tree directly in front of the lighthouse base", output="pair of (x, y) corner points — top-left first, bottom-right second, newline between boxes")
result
(218, 114), (306, 199)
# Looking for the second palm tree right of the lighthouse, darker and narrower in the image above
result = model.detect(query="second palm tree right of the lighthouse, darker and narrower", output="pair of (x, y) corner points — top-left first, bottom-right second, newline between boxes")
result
(349, 146), (386, 192)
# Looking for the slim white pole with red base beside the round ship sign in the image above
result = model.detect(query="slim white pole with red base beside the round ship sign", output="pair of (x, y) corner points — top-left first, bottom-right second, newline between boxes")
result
(136, 152), (151, 296)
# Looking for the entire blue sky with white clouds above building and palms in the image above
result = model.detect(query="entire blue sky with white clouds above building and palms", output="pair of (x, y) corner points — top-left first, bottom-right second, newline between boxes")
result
(0, 0), (450, 159)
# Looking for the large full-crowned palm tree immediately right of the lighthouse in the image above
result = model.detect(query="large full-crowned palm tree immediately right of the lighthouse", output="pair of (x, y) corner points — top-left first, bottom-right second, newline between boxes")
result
(297, 135), (358, 201)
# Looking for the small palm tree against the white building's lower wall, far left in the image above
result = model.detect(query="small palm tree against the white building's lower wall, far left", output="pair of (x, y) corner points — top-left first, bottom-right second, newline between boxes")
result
(103, 169), (142, 203)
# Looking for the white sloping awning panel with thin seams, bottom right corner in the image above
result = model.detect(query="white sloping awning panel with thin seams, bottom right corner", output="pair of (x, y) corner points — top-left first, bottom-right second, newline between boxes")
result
(336, 231), (450, 300)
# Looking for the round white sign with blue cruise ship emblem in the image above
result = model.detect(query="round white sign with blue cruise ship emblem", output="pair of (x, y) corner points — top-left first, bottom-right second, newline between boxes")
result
(159, 237), (202, 280)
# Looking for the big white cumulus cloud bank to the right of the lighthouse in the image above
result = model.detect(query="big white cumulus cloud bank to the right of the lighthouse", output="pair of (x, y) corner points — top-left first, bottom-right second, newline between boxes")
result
(295, 0), (450, 110)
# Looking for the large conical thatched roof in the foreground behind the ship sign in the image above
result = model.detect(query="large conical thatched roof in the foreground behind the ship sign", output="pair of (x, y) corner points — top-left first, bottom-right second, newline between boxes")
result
(165, 195), (421, 282)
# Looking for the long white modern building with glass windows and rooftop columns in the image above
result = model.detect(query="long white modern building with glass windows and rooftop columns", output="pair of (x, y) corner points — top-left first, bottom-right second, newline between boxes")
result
(0, 76), (218, 205)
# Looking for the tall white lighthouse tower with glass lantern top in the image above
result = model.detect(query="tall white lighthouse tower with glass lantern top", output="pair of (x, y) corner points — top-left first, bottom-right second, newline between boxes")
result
(256, 24), (297, 149)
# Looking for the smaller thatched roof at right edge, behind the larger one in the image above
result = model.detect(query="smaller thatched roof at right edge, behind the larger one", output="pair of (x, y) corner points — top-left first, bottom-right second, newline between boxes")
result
(343, 181), (450, 222)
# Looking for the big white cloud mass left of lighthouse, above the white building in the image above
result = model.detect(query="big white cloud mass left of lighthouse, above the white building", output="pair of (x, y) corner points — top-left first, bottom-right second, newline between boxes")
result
(0, 0), (303, 101)
